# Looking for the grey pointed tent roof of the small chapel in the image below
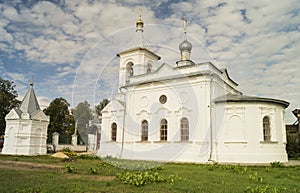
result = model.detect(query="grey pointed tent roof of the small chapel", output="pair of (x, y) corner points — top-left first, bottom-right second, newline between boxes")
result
(20, 82), (41, 115)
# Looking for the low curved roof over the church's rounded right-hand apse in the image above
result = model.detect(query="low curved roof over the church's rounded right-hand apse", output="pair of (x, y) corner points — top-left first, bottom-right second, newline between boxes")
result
(214, 94), (289, 108)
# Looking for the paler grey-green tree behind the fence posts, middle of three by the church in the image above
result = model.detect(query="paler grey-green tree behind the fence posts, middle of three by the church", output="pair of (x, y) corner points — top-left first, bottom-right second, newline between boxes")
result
(72, 101), (93, 144)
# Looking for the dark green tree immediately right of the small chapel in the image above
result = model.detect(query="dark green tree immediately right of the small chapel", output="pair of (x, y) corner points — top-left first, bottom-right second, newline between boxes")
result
(44, 97), (75, 143)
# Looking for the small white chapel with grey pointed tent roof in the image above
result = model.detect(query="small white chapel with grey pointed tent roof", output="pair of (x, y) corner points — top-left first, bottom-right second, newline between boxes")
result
(2, 82), (49, 155)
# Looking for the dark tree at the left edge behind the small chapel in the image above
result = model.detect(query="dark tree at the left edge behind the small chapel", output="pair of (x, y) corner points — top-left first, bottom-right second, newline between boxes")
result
(0, 77), (21, 135)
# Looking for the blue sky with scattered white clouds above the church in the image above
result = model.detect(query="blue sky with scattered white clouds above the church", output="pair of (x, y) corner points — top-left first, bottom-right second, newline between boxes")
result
(0, 0), (300, 123)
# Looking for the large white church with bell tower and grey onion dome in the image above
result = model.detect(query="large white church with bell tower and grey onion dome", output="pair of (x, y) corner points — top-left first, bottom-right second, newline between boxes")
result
(98, 17), (289, 163)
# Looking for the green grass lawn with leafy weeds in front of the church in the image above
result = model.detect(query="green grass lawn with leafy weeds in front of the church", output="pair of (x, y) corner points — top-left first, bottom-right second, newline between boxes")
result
(0, 155), (300, 193)
